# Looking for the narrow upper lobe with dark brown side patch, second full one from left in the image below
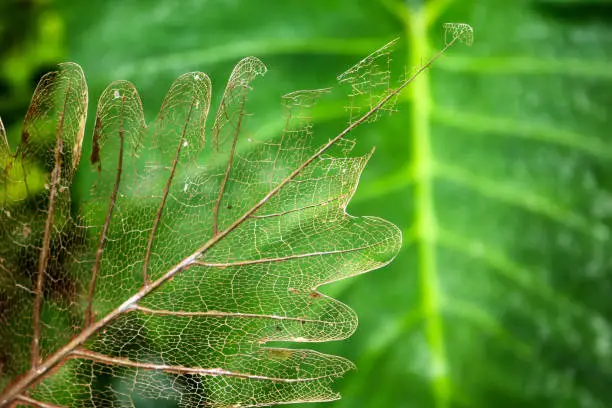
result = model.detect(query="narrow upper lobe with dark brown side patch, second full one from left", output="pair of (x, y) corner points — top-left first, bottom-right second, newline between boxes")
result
(81, 81), (146, 324)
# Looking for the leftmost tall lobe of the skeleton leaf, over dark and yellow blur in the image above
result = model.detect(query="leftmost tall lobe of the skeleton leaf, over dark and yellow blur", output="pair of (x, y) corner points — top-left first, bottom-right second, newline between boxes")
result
(0, 64), (87, 388)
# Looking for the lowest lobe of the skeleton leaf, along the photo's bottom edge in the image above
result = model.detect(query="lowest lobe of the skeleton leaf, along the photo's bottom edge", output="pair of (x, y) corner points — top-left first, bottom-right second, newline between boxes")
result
(37, 356), (354, 408)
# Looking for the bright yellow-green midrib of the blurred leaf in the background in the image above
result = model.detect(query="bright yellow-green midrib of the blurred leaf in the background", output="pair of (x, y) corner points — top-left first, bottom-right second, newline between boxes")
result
(404, 3), (450, 408)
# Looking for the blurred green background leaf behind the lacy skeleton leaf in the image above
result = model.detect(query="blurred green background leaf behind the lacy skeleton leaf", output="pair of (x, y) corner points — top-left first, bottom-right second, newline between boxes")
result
(0, 0), (612, 408)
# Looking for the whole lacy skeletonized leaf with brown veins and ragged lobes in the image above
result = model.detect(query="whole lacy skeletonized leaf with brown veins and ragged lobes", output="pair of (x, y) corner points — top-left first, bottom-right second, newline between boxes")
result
(0, 29), (464, 407)
